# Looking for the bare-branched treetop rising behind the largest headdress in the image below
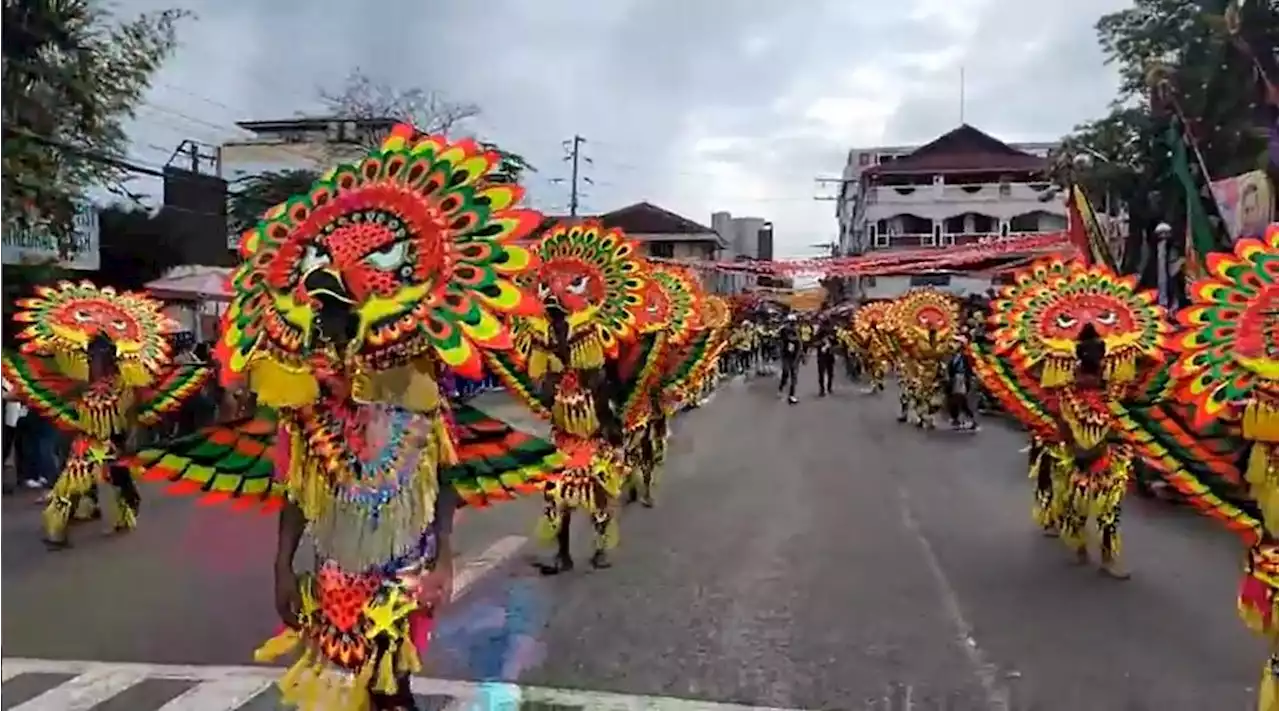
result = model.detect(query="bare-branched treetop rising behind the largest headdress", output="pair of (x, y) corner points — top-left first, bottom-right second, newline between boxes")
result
(320, 68), (536, 183)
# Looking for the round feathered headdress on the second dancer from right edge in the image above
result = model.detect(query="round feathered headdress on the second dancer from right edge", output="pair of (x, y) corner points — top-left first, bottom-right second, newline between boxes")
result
(991, 257), (1171, 387)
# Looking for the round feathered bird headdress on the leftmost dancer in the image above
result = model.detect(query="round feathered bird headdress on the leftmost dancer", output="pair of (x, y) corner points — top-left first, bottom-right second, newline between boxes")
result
(14, 282), (178, 387)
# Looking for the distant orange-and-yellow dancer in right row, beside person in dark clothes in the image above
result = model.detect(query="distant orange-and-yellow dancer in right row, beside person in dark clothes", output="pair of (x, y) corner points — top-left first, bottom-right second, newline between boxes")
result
(887, 288), (960, 429)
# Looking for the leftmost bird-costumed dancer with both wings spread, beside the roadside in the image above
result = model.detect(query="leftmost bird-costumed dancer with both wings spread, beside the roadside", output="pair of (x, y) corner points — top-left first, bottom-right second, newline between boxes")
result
(3, 282), (210, 550)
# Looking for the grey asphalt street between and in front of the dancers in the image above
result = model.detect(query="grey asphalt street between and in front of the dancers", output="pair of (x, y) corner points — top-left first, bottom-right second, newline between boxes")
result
(0, 365), (1263, 711)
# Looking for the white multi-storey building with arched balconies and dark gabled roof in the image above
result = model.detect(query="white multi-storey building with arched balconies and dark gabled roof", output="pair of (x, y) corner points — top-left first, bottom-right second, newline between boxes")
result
(836, 124), (1066, 297)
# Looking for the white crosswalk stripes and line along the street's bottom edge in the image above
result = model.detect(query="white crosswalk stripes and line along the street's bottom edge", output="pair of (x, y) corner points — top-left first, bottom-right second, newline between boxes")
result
(0, 658), (804, 711)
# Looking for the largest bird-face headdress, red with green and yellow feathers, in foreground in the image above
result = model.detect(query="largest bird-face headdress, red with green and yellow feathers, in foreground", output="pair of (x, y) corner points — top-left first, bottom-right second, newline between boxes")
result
(218, 126), (540, 406)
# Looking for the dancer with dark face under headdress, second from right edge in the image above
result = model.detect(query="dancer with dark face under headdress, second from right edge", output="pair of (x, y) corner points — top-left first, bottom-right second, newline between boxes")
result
(974, 259), (1170, 579)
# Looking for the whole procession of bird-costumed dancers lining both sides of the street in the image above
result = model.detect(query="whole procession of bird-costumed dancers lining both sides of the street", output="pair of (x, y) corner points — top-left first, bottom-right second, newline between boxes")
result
(3, 126), (1280, 711)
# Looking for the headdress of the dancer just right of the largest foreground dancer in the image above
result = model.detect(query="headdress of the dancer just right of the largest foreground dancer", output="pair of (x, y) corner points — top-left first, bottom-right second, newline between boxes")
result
(517, 220), (645, 378)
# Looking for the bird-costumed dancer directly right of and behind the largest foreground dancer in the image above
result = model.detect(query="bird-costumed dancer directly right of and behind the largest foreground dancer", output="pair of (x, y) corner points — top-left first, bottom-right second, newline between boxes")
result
(490, 220), (646, 575)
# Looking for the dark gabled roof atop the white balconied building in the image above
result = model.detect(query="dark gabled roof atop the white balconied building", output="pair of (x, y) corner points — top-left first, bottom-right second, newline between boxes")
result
(867, 123), (1048, 176)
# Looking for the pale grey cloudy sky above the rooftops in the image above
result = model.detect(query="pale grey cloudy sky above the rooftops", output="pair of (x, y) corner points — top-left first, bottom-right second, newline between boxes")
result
(118, 0), (1129, 256)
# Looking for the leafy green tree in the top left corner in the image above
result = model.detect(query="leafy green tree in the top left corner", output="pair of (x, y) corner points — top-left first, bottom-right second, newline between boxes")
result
(0, 0), (189, 252)
